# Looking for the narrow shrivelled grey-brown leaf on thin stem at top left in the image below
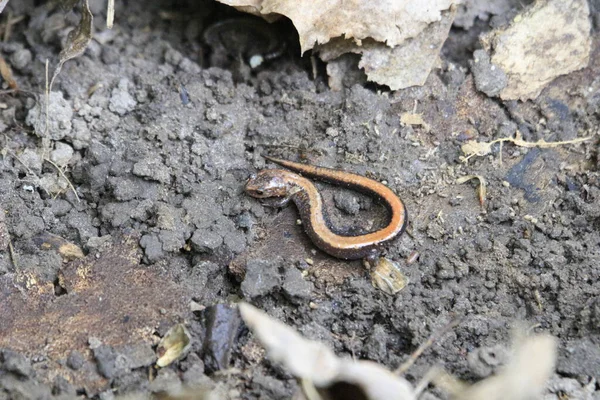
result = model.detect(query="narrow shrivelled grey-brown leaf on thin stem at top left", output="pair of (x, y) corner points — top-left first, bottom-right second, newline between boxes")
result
(49, 0), (94, 91)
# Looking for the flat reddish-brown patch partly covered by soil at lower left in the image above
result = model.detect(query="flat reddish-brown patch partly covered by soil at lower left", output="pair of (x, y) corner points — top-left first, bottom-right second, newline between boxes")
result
(0, 236), (186, 394)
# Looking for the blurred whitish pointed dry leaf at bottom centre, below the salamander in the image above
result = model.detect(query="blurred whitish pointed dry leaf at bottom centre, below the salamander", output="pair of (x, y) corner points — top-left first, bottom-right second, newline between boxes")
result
(239, 303), (415, 400)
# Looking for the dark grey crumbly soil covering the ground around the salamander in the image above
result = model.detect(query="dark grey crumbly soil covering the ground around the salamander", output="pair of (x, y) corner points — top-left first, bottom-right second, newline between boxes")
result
(0, 0), (600, 399)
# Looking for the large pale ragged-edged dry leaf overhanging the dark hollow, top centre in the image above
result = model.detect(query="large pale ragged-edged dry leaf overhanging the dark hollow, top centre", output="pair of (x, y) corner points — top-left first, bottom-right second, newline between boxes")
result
(219, 0), (458, 90)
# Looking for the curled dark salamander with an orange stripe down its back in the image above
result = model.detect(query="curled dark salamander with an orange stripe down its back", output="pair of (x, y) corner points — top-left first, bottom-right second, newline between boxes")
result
(246, 157), (407, 261)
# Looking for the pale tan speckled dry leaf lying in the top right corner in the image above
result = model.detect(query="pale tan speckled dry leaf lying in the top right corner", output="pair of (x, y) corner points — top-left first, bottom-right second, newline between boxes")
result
(483, 0), (592, 100)
